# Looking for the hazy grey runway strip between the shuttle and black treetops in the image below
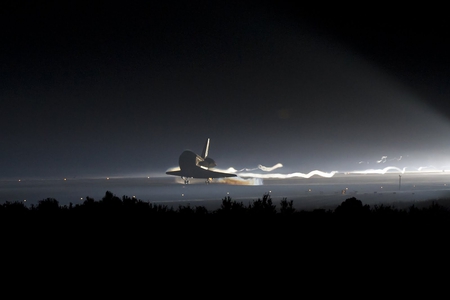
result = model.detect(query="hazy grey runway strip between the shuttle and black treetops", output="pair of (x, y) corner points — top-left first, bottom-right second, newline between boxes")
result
(0, 172), (450, 210)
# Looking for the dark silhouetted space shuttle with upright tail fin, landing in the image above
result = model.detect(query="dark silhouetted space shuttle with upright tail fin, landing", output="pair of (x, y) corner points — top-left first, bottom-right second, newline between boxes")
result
(166, 138), (236, 184)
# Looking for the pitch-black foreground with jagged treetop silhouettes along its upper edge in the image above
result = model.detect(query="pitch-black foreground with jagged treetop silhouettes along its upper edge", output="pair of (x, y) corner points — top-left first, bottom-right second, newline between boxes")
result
(0, 192), (450, 290)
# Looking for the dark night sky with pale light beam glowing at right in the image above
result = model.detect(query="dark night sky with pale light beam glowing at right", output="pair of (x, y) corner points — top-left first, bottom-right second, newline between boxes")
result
(0, 1), (450, 178)
